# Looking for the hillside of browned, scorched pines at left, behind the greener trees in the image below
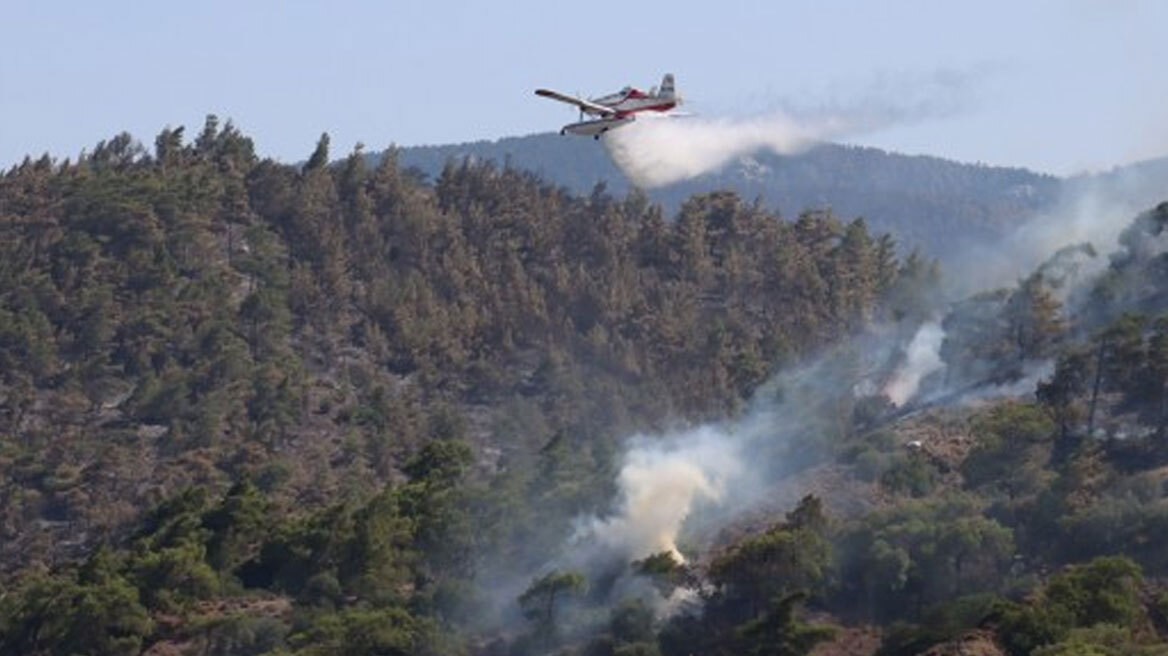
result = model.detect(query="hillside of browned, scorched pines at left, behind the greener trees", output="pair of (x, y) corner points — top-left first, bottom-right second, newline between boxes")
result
(0, 119), (929, 648)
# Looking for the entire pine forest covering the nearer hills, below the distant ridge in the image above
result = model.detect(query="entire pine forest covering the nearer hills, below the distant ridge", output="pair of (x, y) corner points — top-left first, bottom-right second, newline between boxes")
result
(0, 117), (1168, 656)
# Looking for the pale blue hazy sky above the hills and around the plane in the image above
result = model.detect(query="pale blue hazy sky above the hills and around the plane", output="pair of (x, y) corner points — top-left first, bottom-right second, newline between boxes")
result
(0, 0), (1168, 174)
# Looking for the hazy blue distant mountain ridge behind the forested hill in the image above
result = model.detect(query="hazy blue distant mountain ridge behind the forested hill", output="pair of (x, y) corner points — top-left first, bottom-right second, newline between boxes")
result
(398, 133), (1062, 256)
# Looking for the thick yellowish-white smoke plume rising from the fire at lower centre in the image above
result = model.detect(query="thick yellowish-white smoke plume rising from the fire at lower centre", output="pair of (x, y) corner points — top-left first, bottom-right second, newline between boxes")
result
(565, 327), (905, 566)
